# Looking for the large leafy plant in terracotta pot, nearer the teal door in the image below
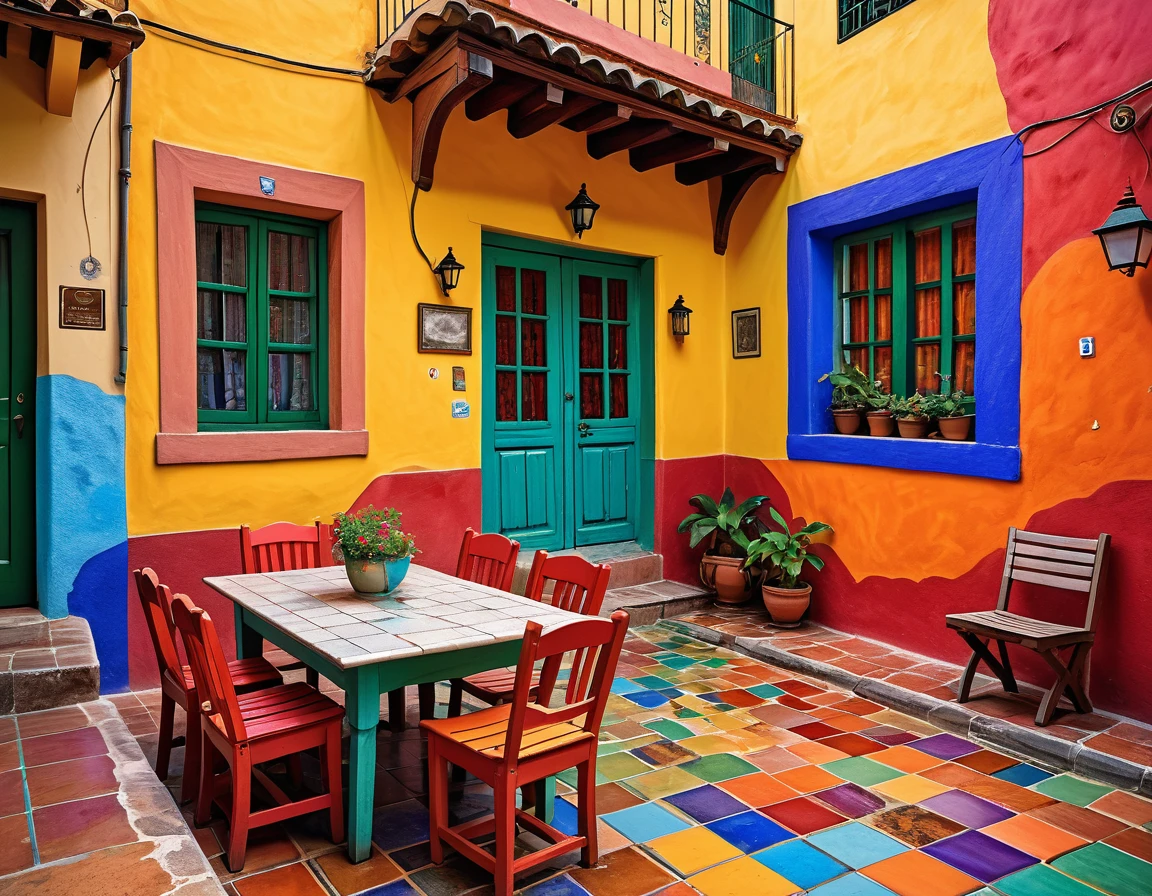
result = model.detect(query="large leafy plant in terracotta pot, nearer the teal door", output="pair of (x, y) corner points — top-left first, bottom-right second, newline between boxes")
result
(676, 488), (768, 605)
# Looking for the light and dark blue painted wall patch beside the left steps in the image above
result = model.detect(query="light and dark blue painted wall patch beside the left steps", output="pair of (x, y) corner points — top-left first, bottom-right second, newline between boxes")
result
(36, 375), (128, 692)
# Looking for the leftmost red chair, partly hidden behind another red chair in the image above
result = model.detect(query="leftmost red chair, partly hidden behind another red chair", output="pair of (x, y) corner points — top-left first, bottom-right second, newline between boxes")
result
(132, 567), (282, 803)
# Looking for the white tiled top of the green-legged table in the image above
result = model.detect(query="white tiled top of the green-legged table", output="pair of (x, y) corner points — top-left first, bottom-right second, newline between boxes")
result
(204, 563), (583, 669)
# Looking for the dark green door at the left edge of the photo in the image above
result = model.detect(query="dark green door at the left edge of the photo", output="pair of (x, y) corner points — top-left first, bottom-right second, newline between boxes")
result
(0, 202), (36, 607)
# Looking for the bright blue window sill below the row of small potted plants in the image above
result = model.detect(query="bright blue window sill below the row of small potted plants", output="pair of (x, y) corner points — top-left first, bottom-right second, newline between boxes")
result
(788, 433), (1020, 483)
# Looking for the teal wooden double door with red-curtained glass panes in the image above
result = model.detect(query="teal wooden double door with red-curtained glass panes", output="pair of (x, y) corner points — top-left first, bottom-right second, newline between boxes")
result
(482, 237), (651, 550)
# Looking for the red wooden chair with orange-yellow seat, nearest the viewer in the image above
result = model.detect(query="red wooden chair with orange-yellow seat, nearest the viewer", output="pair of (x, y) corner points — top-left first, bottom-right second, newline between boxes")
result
(420, 610), (628, 896)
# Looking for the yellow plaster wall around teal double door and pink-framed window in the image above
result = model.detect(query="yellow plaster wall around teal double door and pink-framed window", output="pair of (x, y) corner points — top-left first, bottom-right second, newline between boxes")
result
(127, 0), (729, 536)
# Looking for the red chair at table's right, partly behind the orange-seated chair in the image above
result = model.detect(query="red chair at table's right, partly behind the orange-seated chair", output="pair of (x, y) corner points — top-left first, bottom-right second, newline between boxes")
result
(448, 550), (612, 717)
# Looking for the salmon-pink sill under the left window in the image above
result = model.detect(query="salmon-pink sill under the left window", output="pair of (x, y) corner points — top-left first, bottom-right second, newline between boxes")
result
(156, 430), (367, 464)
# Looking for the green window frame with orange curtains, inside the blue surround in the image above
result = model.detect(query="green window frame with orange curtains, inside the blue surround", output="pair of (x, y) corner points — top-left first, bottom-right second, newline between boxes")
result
(833, 203), (976, 412)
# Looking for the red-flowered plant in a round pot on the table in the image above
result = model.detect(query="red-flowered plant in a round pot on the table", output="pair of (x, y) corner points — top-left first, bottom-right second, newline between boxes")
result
(332, 504), (416, 597)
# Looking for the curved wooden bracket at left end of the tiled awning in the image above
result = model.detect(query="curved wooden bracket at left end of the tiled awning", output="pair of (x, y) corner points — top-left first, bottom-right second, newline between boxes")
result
(403, 41), (493, 191)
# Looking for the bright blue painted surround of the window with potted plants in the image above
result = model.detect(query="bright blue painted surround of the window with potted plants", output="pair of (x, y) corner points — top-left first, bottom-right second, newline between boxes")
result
(788, 137), (1024, 480)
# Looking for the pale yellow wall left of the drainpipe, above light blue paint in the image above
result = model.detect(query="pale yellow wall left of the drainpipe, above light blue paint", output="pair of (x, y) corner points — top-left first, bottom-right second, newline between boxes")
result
(0, 28), (121, 392)
